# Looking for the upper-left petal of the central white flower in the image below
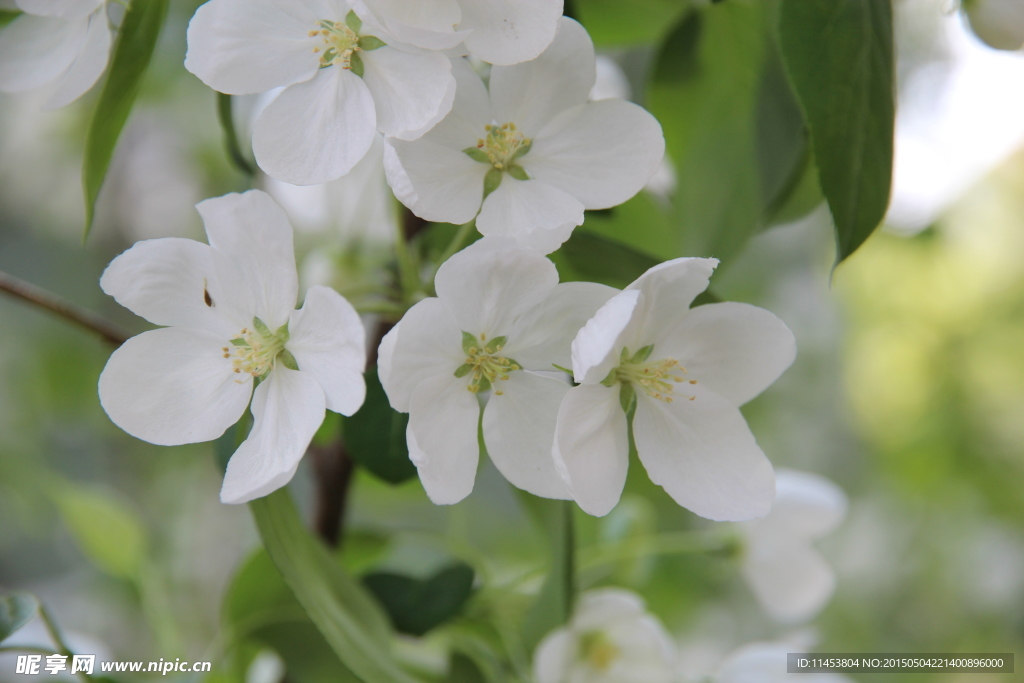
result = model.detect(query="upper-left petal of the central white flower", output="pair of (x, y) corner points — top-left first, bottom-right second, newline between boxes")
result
(378, 298), (466, 413)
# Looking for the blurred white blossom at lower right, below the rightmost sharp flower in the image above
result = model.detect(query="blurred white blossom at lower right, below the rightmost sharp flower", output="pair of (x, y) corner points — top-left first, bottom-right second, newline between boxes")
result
(738, 469), (847, 623)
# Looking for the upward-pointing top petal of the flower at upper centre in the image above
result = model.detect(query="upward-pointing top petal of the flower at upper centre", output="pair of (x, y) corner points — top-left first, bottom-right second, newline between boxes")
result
(490, 18), (597, 132)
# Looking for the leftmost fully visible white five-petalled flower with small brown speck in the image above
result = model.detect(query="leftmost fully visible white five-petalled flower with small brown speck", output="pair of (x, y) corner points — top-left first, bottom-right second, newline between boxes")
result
(99, 190), (366, 503)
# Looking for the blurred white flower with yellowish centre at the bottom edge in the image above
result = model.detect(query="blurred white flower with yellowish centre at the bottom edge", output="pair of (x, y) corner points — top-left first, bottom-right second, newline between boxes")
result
(534, 588), (676, 683)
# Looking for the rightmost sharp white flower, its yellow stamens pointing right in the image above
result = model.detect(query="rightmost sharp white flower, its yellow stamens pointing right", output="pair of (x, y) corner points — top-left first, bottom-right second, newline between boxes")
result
(554, 258), (796, 521)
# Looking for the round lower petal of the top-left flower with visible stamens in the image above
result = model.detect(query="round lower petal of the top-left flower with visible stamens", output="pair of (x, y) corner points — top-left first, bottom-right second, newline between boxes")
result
(253, 67), (377, 185)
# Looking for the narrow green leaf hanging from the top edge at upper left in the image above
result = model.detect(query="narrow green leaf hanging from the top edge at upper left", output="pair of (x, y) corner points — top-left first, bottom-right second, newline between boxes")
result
(82, 0), (168, 238)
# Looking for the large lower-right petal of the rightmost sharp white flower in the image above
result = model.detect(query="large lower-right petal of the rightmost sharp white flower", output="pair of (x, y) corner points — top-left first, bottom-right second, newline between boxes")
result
(633, 384), (775, 521)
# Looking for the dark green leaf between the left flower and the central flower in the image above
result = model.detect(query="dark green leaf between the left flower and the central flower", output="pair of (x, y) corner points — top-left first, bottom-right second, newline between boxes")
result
(345, 367), (416, 484)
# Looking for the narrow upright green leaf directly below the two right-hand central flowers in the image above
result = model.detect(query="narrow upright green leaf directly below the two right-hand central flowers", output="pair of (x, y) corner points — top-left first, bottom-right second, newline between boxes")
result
(517, 492), (575, 651)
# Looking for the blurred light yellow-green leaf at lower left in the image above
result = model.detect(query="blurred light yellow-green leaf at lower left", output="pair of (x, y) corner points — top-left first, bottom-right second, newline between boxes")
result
(53, 484), (146, 581)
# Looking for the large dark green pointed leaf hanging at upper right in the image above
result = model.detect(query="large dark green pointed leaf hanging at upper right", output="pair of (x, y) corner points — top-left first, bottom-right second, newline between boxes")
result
(778, 0), (896, 264)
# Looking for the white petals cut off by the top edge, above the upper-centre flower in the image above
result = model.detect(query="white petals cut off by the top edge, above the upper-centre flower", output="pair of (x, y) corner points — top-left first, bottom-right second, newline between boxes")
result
(353, 0), (562, 65)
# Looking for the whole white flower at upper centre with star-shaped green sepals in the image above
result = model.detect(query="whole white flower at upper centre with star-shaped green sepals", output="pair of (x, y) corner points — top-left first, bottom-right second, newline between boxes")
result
(384, 17), (665, 253)
